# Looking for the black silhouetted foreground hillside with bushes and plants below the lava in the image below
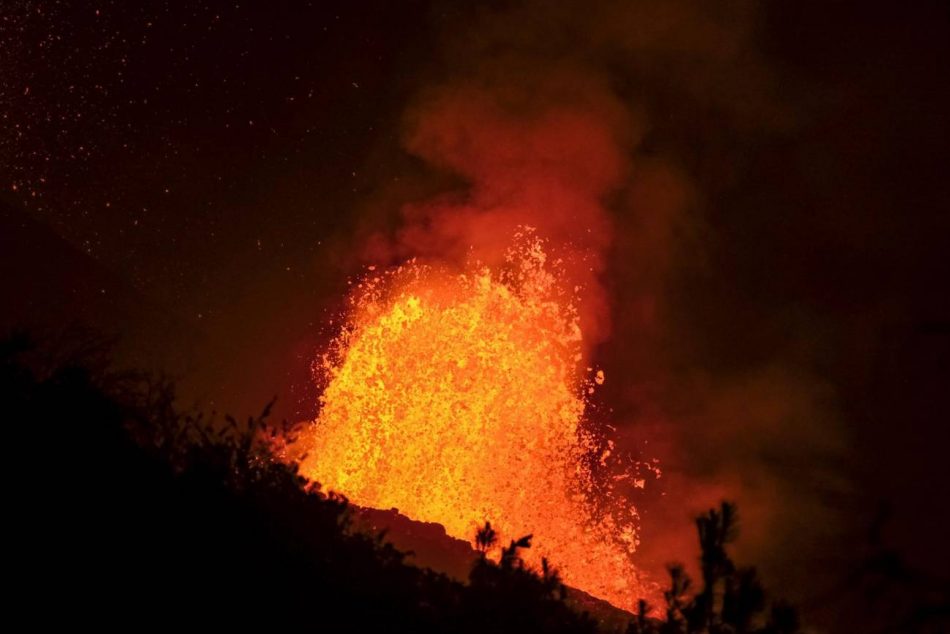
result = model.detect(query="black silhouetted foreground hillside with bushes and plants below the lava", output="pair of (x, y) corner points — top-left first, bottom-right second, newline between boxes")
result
(11, 334), (940, 634)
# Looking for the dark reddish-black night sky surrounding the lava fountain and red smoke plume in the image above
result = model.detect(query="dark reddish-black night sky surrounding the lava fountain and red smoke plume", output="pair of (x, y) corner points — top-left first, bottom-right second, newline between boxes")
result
(0, 0), (950, 628)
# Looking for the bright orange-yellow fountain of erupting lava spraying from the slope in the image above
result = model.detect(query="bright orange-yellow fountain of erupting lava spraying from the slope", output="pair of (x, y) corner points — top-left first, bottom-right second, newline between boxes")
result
(297, 236), (642, 607)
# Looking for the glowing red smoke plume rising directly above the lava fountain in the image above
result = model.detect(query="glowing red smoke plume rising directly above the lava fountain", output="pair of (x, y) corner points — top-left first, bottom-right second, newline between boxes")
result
(369, 70), (636, 353)
